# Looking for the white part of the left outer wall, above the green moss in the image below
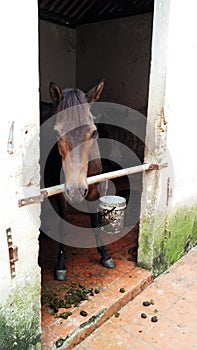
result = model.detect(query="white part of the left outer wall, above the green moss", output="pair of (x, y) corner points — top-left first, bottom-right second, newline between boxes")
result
(0, 0), (39, 297)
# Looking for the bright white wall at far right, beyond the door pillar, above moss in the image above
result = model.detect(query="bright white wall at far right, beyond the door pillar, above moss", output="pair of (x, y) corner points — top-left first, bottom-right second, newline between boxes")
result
(165, 0), (197, 206)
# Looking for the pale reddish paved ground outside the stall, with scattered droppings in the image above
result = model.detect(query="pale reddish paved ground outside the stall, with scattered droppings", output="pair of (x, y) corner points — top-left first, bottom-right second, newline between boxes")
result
(75, 247), (197, 350)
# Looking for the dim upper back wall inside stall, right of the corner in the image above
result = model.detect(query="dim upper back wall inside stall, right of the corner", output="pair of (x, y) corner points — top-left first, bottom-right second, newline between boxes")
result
(77, 14), (152, 112)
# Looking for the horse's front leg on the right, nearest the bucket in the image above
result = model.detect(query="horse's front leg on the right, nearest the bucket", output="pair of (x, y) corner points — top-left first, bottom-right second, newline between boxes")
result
(87, 187), (116, 269)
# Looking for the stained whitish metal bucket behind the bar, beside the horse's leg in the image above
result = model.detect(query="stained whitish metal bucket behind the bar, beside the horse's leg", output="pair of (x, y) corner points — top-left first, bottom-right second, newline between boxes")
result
(98, 196), (126, 234)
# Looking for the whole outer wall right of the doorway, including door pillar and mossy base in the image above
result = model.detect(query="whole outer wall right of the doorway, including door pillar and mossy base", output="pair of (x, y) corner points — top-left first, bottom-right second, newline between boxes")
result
(138, 0), (197, 275)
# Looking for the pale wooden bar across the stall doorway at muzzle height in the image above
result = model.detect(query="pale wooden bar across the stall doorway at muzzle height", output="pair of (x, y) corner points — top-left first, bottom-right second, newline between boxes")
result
(18, 164), (159, 207)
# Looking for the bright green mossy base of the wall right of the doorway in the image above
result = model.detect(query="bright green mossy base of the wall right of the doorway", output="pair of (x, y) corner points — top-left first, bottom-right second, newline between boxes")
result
(138, 206), (197, 276)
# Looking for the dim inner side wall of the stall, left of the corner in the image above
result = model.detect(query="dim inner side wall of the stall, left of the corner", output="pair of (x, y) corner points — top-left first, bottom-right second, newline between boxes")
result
(39, 20), (76, 101)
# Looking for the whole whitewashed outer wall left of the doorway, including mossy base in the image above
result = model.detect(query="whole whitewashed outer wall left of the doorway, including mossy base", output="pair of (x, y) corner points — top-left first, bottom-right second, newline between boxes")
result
(0, 0), (41, 350)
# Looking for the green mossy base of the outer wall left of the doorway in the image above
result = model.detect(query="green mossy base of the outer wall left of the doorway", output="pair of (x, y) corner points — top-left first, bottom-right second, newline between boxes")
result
(0, 285), (41, 350)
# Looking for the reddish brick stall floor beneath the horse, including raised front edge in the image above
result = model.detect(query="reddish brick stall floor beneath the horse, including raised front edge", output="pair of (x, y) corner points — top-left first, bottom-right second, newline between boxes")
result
(40, 217), (152, 350)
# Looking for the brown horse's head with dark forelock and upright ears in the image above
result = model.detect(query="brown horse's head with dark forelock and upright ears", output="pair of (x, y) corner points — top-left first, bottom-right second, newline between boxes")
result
(49, 81), (104, 203)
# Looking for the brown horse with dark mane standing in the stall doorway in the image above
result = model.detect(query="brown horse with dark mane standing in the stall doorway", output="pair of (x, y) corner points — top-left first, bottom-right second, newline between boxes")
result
(40, 80), (115, 281)
